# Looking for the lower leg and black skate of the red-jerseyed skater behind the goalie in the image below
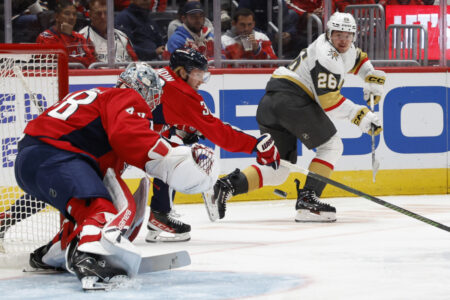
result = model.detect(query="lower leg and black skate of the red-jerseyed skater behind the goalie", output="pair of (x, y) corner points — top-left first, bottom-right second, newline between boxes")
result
(145, 178), (191, 243)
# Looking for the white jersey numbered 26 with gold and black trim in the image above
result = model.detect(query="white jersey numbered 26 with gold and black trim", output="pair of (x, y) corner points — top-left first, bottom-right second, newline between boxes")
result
(266, 33), (373, 112)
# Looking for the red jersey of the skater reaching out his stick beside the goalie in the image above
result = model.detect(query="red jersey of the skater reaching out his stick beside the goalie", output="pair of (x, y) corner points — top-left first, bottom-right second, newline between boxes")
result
(153, 67), (257, 153)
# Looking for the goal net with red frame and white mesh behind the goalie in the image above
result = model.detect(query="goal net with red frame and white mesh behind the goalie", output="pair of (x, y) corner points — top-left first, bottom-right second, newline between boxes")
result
(0, 44), (68, 258)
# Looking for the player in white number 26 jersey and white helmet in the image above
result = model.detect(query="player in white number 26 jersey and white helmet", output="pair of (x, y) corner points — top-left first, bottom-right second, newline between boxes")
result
(203, 12), (386, 222)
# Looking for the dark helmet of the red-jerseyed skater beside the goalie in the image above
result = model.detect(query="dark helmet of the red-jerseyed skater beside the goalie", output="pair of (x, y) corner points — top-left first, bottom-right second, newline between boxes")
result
(169, 48), (208, 73)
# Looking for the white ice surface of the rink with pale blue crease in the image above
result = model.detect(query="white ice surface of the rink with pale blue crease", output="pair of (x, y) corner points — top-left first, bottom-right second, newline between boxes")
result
(0, 195), (450, 300)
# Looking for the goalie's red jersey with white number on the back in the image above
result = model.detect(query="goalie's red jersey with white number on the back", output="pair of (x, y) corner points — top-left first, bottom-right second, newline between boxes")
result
(25, 88), (160, 173)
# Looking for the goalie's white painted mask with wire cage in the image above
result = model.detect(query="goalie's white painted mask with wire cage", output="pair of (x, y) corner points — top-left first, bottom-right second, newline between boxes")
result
(116, 62), (162, 110)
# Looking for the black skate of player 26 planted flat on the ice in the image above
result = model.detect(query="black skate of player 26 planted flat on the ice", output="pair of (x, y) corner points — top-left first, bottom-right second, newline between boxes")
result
(295, 179), (336, 222)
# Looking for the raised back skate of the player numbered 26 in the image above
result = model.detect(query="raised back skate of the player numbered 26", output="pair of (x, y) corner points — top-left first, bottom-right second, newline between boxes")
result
(202, 170), (234, 222)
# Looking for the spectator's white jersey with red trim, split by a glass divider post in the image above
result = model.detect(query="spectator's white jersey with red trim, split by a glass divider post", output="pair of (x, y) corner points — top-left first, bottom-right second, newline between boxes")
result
(79, 26), (138, 62)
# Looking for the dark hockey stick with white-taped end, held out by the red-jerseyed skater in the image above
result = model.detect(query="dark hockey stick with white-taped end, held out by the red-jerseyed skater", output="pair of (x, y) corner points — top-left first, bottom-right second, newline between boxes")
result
(281, 160), (450, 231)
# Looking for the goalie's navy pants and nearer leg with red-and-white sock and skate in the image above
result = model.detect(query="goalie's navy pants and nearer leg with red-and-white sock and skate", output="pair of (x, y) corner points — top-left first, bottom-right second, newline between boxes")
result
(15, 145), (133, 281)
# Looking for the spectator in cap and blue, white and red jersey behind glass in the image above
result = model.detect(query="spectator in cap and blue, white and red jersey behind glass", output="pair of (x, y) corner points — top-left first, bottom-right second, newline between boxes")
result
(165, 1), (214, 59)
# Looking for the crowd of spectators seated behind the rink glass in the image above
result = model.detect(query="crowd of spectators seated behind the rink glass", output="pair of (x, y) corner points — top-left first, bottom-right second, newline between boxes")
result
(0, 0), (435, 67)
